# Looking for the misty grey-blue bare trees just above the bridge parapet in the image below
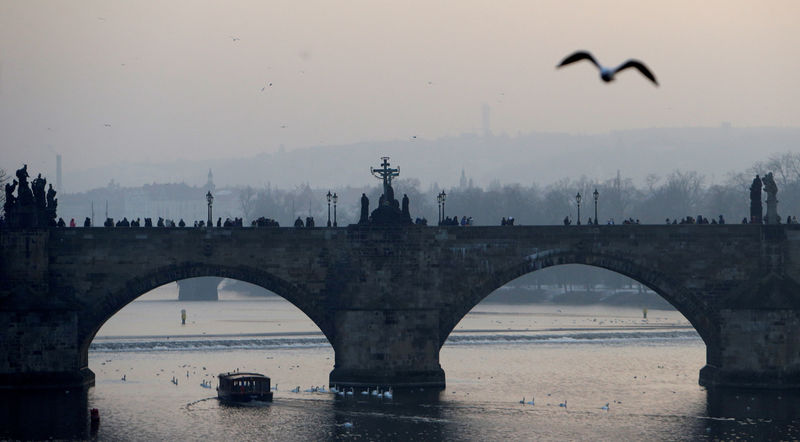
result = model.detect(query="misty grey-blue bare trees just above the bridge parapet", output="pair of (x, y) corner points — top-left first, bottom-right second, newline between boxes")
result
(244, 152), (800, 226)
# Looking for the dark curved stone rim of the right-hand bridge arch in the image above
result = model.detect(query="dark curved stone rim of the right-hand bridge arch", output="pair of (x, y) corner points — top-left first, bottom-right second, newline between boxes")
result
(439, 249), (719, 361)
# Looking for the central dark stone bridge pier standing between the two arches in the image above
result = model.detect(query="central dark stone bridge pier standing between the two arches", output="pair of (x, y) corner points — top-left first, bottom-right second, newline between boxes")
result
(330, 309), (445, 389)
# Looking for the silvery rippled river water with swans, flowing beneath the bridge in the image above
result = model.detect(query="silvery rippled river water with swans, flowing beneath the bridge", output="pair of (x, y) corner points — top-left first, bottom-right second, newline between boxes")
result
(81, 284), (800, 441)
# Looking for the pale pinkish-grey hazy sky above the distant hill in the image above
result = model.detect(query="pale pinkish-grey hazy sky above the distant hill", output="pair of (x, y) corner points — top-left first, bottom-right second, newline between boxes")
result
(0, 0), (800, 178)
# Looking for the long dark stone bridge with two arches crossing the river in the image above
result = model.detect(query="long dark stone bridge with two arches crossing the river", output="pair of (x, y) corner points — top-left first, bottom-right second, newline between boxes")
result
(0, 225), (800, 390)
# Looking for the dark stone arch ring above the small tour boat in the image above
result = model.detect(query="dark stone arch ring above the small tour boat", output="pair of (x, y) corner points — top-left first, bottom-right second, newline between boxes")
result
(78, 262), (334, 363)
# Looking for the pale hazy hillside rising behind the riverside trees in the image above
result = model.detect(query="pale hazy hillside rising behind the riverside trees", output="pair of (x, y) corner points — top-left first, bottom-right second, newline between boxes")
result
(64, 126), (800, 192)
